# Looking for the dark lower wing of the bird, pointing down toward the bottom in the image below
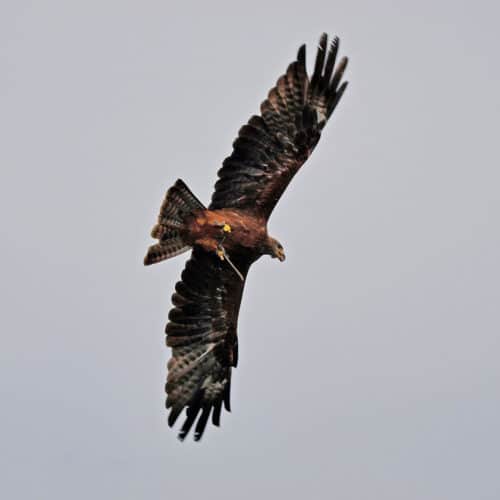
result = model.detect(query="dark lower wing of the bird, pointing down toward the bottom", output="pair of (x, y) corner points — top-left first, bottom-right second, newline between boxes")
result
(166, 247), (253, 441)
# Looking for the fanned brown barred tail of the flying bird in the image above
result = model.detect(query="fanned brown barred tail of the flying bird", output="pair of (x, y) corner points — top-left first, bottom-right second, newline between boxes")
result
(144, 179), (205, 266)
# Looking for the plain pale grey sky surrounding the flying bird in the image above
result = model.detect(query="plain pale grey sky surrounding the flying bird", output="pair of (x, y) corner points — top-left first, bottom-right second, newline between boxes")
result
(0, 0), (500, 500)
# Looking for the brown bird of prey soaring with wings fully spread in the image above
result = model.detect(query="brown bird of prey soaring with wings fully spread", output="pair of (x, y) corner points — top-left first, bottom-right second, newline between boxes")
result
(144, 34), (347, 441)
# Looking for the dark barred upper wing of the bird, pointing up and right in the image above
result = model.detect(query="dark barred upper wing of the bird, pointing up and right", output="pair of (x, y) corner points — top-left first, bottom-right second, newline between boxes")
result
(209, 34), (347, 218)
